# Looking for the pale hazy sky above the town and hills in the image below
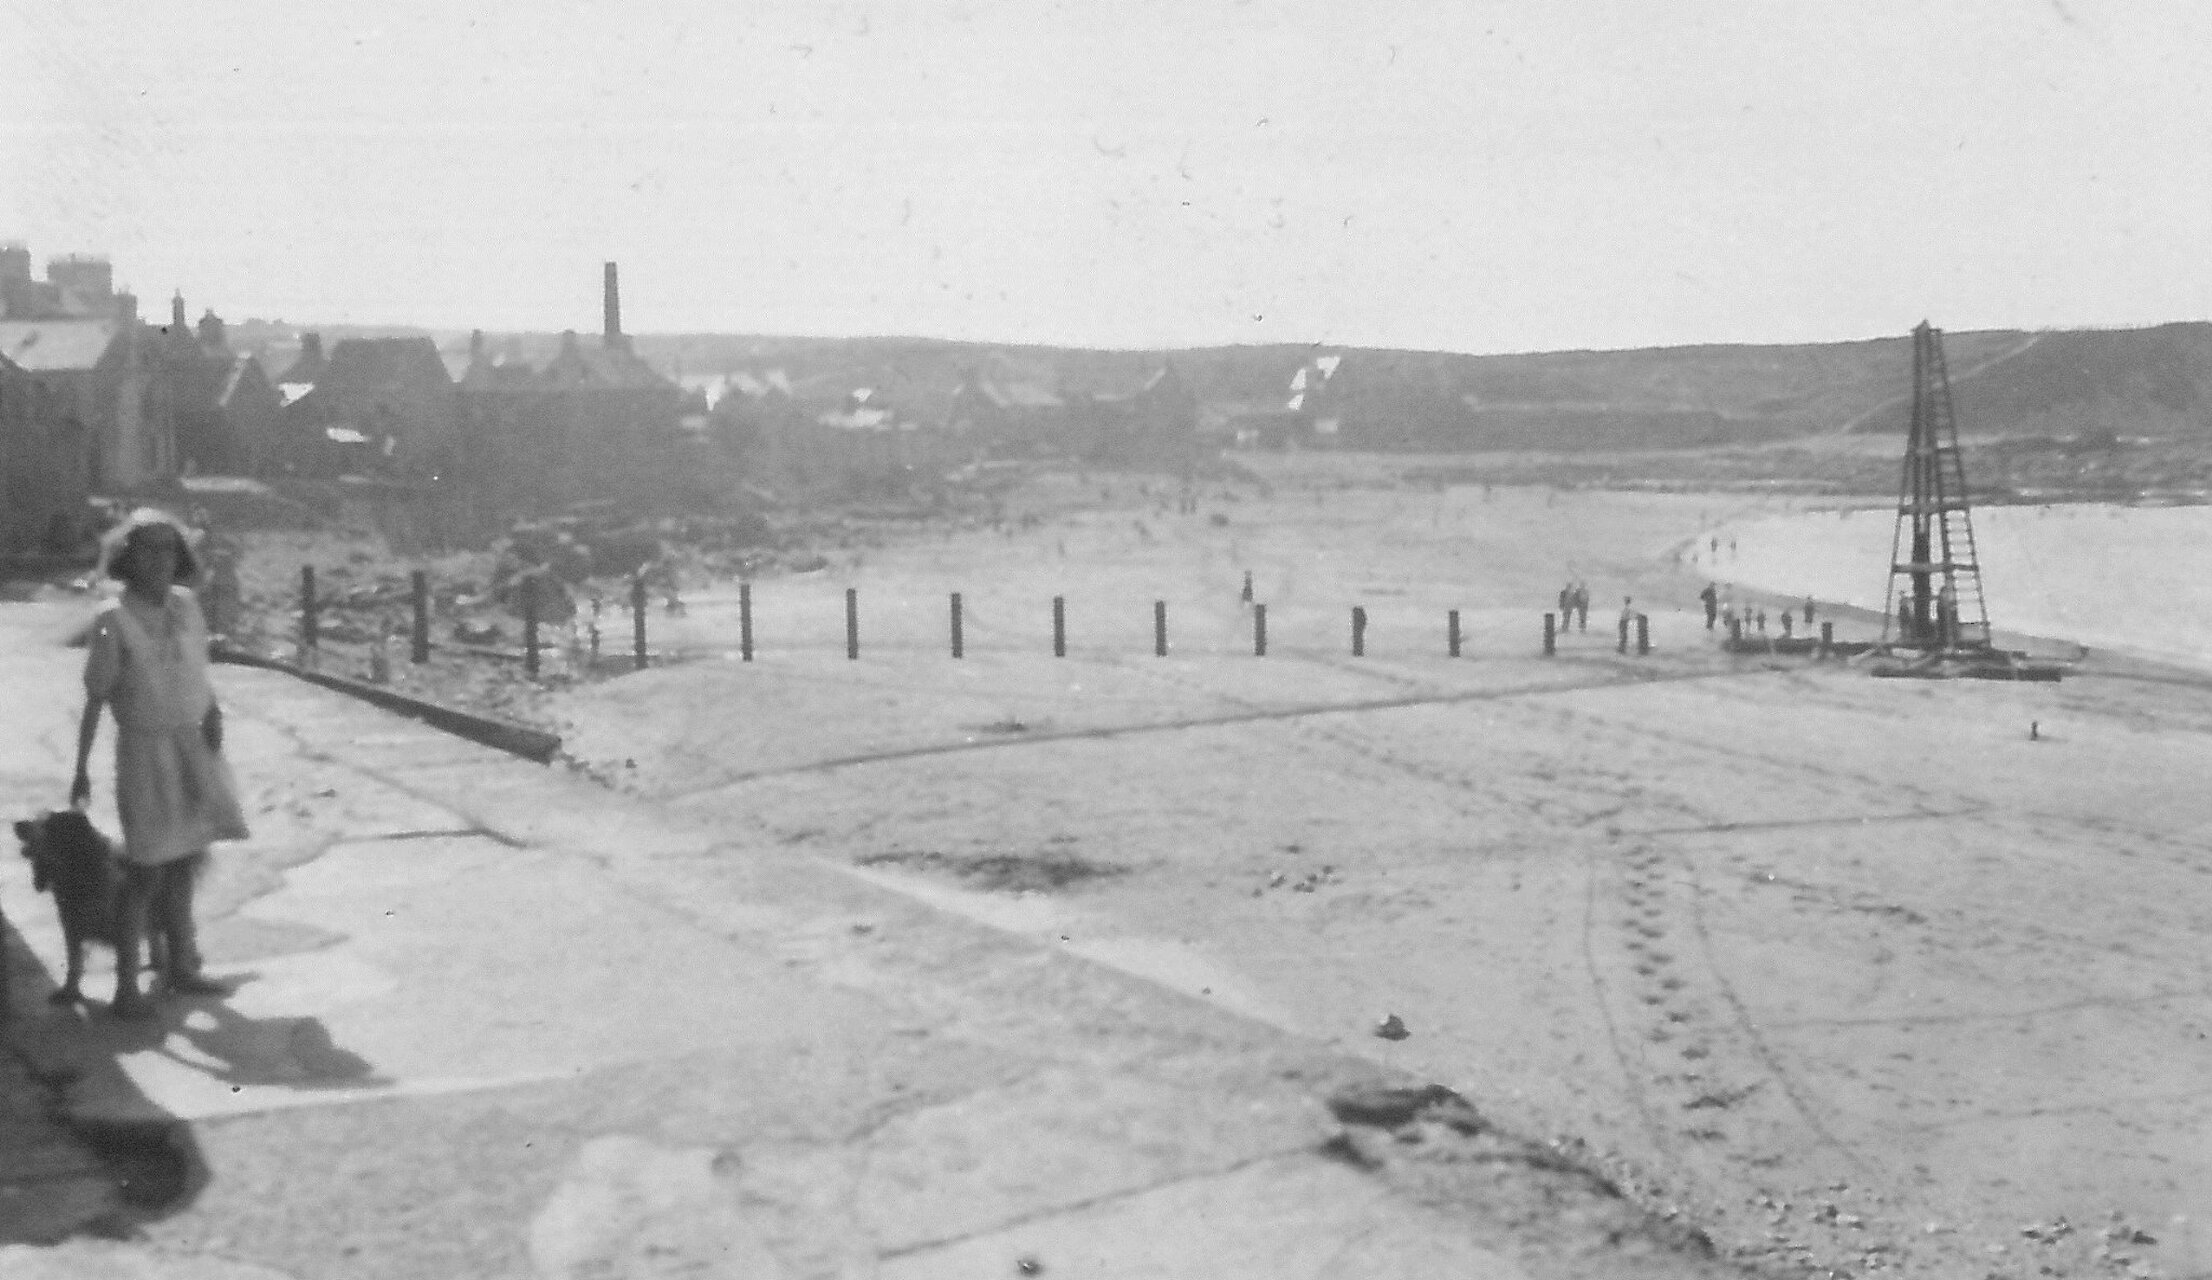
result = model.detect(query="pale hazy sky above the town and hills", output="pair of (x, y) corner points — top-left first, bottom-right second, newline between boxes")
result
(0, 0), (2212, 352)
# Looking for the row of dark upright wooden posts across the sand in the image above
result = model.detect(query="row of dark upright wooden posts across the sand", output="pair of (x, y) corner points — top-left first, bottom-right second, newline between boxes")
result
(299, 566), (1672, 676)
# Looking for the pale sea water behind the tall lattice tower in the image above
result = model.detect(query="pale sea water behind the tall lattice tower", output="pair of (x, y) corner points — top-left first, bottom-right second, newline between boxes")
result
(1697, 504), (2212, 665)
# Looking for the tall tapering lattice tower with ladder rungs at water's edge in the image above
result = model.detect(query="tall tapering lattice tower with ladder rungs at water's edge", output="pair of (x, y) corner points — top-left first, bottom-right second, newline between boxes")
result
(1882, 321), (1991, 652)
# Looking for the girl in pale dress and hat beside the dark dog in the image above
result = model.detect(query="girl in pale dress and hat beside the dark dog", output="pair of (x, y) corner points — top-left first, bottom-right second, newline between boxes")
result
(69, 508), (248, 1017)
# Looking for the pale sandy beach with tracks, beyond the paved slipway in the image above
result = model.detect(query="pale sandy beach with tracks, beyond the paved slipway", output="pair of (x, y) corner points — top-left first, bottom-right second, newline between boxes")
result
(526, 455), (2212, 1278)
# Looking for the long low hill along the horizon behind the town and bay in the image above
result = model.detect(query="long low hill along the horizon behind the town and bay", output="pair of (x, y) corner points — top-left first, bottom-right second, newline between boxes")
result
(242, 323), (2212, 451)
